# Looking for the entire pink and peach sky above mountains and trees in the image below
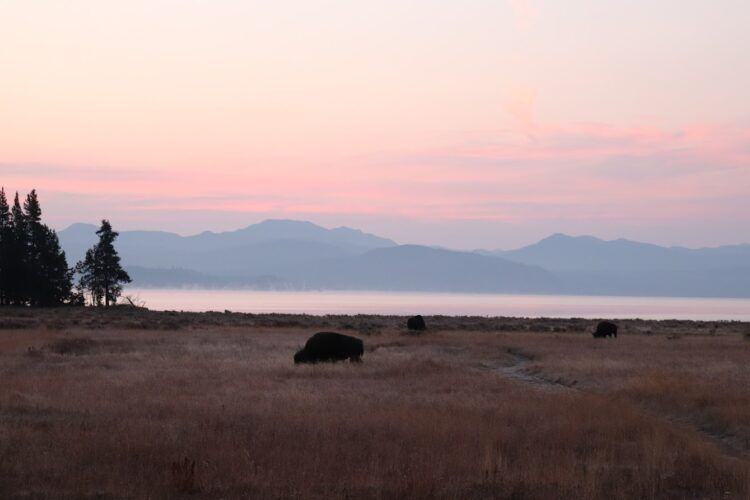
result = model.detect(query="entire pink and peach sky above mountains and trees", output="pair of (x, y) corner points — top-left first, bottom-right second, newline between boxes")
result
(0, 0), (750, 249)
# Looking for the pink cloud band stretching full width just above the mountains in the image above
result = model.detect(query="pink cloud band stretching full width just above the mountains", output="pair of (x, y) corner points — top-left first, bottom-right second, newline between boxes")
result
(0, 124), (750, 242)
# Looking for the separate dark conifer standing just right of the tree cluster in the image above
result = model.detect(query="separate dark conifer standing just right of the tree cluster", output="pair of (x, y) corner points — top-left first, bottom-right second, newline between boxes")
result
(76, 219), (131, 306)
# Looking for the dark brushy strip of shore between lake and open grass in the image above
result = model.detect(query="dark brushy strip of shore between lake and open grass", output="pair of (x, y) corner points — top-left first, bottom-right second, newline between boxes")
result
(0, 305), (750, 336)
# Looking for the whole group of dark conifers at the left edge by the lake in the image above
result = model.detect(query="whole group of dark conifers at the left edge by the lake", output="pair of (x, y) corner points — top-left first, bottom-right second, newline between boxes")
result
(0, 188), (130, 307)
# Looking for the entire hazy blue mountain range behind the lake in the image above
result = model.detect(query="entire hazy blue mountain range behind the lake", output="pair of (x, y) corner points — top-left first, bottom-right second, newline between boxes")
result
(59, 220), (750, 297)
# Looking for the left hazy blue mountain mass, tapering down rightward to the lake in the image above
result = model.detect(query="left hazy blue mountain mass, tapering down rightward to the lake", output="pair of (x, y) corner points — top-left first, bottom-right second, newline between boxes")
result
(60, 220), (557, 293)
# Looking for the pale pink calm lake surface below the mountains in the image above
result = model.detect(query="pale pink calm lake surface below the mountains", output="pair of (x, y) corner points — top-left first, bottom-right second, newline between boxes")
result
(125, 288), (750, 321)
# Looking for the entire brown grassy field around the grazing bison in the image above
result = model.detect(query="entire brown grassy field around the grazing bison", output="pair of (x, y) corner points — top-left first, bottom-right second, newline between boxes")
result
(0, 308), (750, 499)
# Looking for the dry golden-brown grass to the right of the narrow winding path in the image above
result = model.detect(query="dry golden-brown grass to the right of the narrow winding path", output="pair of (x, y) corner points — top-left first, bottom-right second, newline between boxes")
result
(502, 335), (750, 453)
